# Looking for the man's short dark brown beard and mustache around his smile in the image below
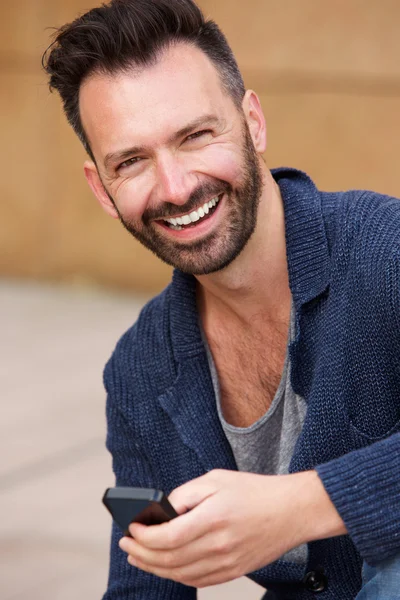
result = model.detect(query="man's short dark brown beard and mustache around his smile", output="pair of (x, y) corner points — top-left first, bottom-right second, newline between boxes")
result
(107, 122), (263, 275)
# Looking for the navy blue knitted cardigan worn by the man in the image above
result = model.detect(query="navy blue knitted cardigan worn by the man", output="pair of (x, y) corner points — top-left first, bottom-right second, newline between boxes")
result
(104, 169), (400, 600)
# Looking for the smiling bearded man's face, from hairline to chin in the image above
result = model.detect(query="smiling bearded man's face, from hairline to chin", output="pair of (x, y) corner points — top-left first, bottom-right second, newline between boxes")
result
(80, 44), (263, 275)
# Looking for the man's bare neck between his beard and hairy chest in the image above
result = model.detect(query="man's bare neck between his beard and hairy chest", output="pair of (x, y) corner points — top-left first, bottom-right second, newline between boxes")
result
(197, 169), (291, 325)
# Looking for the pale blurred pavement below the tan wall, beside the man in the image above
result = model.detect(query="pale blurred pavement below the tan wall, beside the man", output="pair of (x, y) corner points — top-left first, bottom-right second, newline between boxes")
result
(0, 280), (263, 600)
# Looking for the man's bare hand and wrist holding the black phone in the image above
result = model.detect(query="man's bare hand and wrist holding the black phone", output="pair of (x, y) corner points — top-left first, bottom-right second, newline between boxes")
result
(120, 470), (346, 588)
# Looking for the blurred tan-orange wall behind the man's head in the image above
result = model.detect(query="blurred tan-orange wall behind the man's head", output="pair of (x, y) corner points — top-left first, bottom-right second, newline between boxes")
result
(0, 0), (400, 290)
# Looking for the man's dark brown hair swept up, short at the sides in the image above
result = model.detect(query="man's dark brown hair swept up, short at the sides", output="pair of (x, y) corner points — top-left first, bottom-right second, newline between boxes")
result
(42, 0), (245, 159)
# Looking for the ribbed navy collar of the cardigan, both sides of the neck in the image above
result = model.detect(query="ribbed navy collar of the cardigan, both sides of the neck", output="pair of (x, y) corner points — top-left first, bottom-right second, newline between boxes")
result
(170, 168), (330, 362)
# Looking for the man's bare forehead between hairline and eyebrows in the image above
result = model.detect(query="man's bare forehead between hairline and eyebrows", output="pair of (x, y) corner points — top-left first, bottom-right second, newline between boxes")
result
(80, 44), (234, 154)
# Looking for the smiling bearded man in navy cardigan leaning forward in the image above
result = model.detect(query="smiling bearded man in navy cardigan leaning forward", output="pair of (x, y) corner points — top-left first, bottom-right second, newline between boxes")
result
(45, 0), (400, 600)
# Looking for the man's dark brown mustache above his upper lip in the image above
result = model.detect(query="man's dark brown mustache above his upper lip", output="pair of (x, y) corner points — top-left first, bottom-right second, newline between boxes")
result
(142, 181), (232, 225)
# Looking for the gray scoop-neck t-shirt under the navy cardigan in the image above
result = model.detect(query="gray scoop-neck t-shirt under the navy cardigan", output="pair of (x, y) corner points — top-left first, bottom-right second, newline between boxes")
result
(203, 308), (308, 564)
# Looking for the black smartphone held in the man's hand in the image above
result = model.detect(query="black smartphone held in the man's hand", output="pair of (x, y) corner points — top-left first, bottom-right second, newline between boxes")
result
(103, 487), (178, 536)
